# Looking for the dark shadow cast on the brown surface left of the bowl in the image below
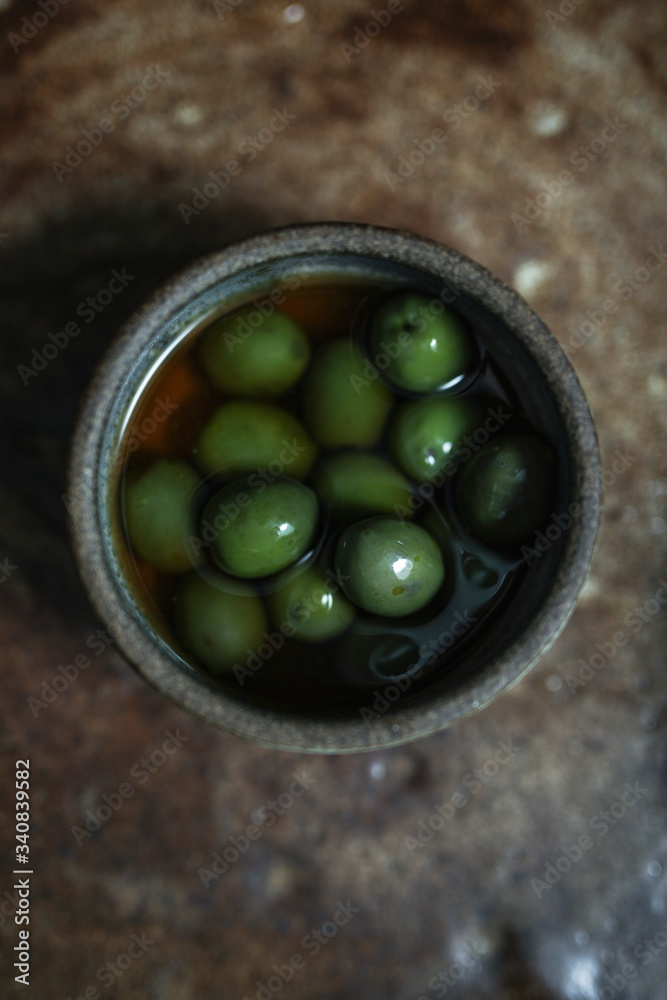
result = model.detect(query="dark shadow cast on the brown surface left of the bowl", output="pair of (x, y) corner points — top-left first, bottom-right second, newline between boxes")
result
(0, 201), (272, 624)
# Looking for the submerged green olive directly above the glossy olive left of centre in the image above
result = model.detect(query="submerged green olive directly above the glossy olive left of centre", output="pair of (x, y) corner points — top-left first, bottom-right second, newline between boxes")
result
(193, 400), (317, 479)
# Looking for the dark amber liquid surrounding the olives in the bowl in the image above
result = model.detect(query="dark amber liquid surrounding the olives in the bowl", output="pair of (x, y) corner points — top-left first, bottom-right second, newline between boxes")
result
(119, 279), (548, 714)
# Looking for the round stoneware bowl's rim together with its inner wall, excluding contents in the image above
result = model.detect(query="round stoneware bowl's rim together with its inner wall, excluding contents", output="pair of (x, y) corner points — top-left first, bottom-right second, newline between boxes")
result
(69, 223), (600, 752)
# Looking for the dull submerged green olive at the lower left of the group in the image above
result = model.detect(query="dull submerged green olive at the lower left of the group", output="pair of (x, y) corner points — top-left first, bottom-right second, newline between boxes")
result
(175, 573), (267, 674)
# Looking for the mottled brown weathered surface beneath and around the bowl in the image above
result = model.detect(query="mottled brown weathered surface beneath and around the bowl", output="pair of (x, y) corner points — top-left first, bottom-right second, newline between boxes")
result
(0, 0), (667, 1000)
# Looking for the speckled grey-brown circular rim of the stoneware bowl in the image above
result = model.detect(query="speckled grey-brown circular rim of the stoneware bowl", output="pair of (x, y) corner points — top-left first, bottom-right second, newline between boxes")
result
(69, 222), (601, 753)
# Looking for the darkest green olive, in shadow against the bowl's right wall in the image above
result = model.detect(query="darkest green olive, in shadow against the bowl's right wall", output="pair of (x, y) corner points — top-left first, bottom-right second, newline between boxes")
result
(456, 434), (554, 545)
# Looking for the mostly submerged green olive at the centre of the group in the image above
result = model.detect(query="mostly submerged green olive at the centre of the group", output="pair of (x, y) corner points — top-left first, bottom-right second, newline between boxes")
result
(313, 451), (410, 515)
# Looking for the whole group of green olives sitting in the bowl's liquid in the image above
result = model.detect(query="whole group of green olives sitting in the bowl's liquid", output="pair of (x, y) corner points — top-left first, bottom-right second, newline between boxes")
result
(124, 292), (548, 673)
